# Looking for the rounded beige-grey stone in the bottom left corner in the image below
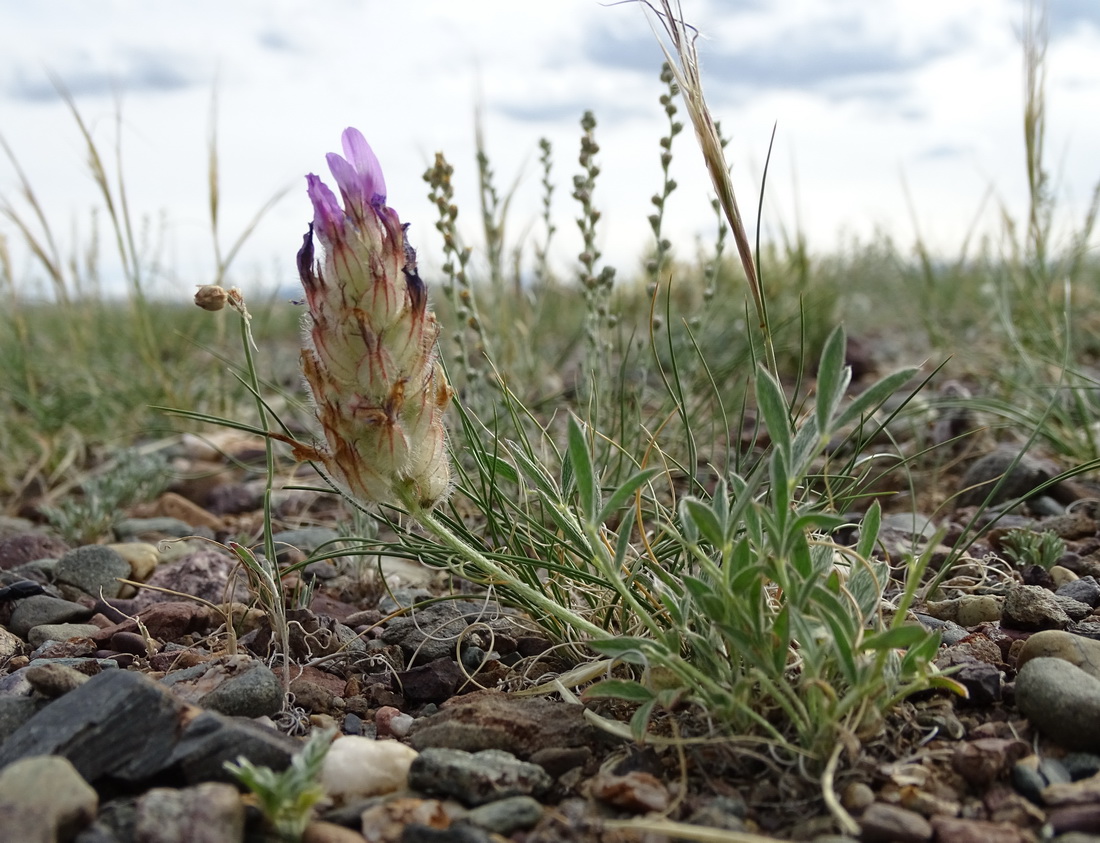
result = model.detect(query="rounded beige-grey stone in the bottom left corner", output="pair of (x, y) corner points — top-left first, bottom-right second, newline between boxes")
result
(0, 755), (99, 843)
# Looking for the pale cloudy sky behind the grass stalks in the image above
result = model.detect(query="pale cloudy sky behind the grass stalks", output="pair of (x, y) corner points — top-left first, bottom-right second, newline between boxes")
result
(0, 0), (1100, 295)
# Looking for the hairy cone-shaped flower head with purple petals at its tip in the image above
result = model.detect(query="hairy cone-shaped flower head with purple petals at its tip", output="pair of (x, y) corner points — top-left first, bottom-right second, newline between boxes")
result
(297, 129), (451, 508)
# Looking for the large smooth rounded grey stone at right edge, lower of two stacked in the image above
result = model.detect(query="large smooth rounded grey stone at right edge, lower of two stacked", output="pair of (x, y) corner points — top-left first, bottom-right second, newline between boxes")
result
(1016, 656), (1100, 753)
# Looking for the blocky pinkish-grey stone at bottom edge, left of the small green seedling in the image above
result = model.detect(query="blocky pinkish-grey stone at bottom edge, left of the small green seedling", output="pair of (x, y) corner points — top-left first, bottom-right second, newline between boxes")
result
(134, 781), (244, 843)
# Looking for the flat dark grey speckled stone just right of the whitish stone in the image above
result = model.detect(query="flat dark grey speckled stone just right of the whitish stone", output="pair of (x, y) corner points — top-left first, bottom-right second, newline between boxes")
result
(409, 748), (553, 806)
